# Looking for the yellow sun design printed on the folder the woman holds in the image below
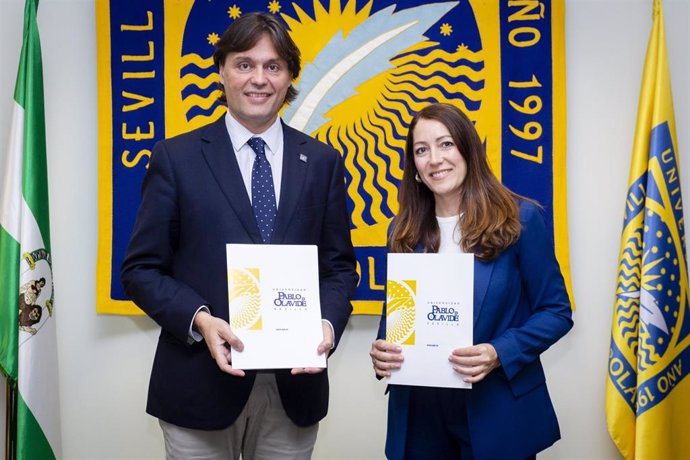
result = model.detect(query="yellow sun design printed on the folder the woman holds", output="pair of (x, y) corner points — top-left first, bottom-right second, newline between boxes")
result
(386, 280), (417, 345)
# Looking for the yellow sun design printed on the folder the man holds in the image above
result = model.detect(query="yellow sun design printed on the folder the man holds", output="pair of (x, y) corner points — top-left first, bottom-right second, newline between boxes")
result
(228, 268), (262, 330)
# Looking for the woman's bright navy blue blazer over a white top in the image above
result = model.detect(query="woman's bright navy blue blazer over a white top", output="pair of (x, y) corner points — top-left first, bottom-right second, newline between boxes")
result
(379, 202), (573, 460)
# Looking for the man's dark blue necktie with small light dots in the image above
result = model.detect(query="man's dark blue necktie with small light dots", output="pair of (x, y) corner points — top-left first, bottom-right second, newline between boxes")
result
(247, 137), (276, 243)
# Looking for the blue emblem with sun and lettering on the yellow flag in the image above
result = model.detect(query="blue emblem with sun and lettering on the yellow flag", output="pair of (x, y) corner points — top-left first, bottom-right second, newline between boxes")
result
(609, 121), (690, 415)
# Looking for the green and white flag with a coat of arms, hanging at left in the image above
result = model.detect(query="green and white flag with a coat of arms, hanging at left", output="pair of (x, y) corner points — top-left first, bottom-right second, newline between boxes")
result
(0, 0), (61, 459)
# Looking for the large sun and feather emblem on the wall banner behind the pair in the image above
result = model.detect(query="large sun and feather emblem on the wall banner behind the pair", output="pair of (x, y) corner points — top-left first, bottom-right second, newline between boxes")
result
(172, 0), (487, 312)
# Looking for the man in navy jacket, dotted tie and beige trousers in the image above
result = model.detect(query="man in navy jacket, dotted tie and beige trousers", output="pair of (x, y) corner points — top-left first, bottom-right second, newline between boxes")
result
(121, 13), (357, 459)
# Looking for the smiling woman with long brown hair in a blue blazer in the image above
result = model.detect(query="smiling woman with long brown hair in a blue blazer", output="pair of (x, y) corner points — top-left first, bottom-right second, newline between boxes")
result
(370, 104), (572, 460)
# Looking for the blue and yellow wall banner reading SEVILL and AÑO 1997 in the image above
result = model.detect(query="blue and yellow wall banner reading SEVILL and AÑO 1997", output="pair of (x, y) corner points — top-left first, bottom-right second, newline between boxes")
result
(96, 0), (572, 314)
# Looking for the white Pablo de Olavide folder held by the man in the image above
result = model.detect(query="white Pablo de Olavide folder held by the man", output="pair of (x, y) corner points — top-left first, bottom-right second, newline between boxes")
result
(226, 244), (326, 369)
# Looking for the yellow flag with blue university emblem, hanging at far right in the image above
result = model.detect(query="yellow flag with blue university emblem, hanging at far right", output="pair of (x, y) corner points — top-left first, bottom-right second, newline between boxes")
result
(606, 1), (690, 459)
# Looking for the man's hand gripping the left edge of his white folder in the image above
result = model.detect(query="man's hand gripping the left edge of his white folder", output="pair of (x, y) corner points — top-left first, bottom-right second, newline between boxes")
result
(194, 311), (244, 377)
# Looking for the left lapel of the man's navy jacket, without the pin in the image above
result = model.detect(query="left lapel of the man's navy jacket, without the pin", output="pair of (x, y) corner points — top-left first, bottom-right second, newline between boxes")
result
(201, 117), (261, 243)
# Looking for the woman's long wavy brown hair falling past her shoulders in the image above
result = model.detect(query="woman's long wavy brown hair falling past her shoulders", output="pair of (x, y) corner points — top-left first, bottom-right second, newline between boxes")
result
(389, 104), (524, 260)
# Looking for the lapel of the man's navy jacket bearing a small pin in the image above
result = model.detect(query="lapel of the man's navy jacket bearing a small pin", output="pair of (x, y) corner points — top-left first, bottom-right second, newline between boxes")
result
(271, 123), (309, 244)
